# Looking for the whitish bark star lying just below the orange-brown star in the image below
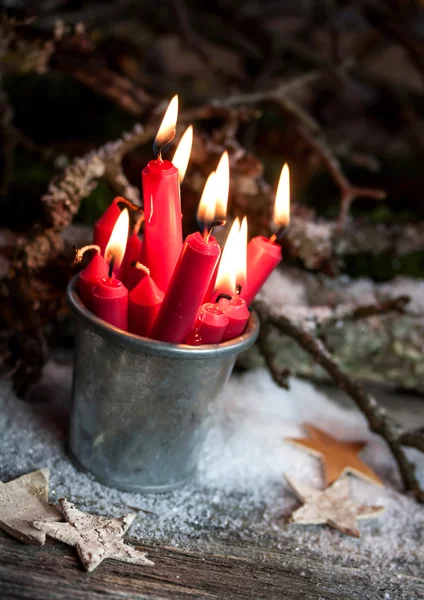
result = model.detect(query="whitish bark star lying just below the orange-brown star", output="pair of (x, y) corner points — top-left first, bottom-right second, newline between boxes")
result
(285, 475), (384, 537)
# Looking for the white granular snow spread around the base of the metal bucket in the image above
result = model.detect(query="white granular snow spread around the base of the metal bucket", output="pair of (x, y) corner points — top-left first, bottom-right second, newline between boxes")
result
(0, 363), (424, 580)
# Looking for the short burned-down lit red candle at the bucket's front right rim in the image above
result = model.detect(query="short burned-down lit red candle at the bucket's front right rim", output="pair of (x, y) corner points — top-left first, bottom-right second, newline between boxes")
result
(216, 217), (250, 342)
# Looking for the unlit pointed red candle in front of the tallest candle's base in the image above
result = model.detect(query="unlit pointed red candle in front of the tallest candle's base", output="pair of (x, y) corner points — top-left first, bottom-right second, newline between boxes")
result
(128, 262), (163, 337)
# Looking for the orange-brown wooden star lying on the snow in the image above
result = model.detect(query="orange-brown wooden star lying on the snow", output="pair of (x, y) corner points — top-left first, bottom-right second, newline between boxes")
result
(286, 423), (383, 487)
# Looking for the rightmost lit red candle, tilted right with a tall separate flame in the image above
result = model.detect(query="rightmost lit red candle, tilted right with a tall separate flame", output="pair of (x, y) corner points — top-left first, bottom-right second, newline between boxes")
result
(241, 165), (290, 306)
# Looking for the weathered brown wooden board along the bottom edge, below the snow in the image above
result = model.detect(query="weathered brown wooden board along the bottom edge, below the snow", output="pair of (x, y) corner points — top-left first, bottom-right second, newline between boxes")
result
(0, 533), (424, 600)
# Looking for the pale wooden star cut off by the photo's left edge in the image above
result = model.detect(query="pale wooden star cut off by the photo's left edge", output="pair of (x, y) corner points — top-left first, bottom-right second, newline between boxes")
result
(0, 469), (62, 546)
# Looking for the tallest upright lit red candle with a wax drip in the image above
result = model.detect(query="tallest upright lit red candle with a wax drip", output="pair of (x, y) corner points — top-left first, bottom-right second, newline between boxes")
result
(143, 96), (183, 292)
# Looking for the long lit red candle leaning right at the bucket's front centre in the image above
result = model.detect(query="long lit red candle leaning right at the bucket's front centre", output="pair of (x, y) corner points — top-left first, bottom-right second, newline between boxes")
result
(150, 166), (229, 344)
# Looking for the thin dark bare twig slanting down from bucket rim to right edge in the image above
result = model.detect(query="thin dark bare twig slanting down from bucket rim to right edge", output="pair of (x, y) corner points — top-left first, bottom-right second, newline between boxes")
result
(255, 302), (424, 503)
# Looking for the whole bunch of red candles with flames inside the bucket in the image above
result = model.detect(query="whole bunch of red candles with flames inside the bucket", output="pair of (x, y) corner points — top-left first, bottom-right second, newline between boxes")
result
(76, 96), (290, 346)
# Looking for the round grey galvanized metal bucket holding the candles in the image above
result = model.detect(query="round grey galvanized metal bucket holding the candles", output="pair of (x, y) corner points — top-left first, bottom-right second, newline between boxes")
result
(67, 276), (259, 492)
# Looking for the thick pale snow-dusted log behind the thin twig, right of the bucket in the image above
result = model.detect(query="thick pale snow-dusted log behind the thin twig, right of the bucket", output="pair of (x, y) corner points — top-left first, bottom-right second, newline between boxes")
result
(239, 270), (424, 393)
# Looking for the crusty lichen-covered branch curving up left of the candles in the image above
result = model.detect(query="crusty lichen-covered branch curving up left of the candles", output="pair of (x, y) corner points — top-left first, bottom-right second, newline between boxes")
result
(0, 125), (155, 394)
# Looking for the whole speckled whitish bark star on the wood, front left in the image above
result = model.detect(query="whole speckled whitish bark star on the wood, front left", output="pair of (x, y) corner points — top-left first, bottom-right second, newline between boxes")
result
(33, 498), (154, 571)
